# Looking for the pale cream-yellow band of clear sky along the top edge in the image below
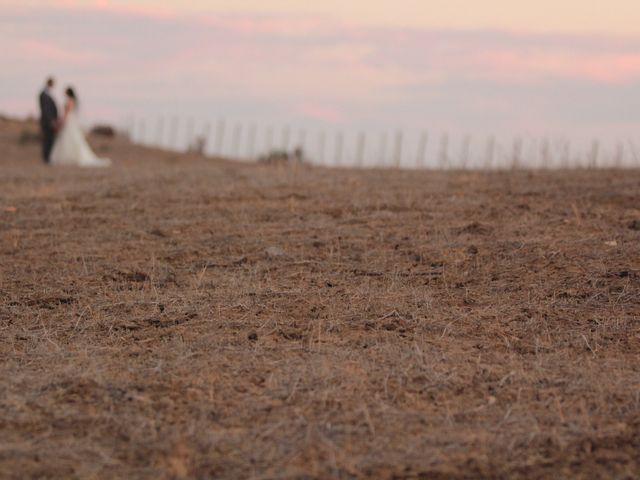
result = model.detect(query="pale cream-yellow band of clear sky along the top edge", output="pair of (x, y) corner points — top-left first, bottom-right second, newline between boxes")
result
(20, 0), (640, 34)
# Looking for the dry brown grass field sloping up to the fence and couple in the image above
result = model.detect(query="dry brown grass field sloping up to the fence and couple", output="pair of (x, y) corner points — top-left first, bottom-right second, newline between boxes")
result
(0, 117), (640, 479)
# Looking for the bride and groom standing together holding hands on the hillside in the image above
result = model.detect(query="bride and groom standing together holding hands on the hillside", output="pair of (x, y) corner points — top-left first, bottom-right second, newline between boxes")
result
(40, 78), (111, 167)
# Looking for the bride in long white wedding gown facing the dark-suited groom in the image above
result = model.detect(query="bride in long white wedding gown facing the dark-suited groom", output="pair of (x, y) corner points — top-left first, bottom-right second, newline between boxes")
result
(51, 88), (111, 167)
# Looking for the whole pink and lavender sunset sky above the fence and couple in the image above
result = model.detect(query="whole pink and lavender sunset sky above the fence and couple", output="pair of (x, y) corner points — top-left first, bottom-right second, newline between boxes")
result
(0, 0), (640, 157)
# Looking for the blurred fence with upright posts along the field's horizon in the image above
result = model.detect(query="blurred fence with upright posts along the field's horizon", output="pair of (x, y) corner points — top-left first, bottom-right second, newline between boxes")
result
(123, 114), (640, 169)
